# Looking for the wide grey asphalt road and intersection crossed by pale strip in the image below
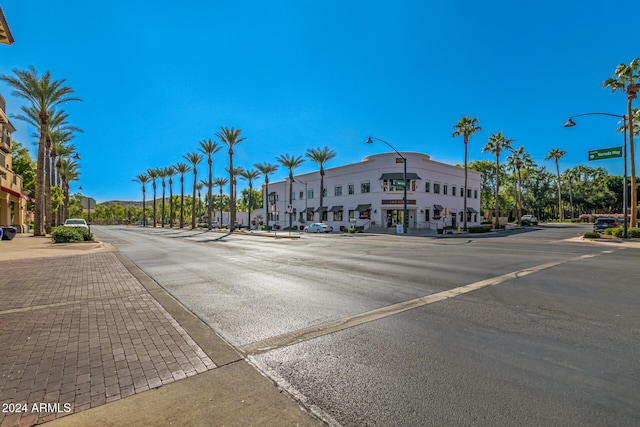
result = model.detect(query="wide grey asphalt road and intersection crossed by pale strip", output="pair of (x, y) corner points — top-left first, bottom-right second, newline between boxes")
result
(94, 226), (640, 426)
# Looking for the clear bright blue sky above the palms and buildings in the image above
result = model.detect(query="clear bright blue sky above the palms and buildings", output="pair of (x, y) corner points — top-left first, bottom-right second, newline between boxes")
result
(0, 0), (640, 202)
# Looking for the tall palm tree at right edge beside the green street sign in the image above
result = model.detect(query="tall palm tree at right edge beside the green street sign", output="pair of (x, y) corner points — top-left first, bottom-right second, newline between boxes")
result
(602, 58), (640, 227)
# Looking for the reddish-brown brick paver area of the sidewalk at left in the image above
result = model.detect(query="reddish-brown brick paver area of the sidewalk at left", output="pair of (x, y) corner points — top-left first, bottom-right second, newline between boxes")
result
(0, 252), (215, 427)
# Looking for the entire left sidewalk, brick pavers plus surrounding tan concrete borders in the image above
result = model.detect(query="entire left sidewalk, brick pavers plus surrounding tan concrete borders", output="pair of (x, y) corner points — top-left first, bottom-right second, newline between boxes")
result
(0, 234), (323, 427)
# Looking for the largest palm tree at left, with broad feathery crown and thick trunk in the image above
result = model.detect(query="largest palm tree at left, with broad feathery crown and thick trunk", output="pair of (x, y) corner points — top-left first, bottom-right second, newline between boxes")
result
(0, 66), (80, 236)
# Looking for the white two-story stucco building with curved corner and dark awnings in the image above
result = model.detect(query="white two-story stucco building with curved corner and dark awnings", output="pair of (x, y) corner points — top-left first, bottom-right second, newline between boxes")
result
(252, 152), (480, 234)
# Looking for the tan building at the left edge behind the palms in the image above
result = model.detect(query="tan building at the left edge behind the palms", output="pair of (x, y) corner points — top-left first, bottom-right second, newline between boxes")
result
(0, 95), (28, 232)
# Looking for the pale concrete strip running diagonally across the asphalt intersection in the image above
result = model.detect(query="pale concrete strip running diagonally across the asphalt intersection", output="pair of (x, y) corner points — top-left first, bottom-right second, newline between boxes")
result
(238, 252), (605, 356)
